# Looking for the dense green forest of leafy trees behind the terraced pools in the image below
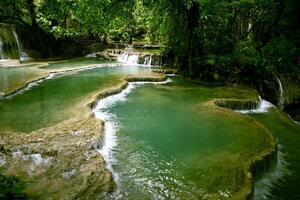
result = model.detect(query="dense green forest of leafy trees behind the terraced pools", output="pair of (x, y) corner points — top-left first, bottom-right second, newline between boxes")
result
(0, 0), (300, 112)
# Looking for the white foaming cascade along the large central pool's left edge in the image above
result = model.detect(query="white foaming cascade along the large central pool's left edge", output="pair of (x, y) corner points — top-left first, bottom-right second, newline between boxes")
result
(93, 79), (171, 184)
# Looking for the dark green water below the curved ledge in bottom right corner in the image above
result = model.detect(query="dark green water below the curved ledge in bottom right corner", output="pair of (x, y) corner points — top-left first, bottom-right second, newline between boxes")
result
(251, 109), (300, 200)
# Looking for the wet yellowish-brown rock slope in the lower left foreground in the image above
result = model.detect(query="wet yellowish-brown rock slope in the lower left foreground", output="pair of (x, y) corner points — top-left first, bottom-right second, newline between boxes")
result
(0, 116), (115, 199)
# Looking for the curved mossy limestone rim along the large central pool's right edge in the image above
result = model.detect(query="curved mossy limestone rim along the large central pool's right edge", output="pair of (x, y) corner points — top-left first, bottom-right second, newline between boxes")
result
(204, 99), (278, 200)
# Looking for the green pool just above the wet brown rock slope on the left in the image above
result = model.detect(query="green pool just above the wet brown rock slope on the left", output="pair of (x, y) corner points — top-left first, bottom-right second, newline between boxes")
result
(0, 63), (148, 132)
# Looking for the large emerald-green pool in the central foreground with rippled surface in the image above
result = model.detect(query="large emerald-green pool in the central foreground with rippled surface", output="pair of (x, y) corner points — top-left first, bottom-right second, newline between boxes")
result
(98, 79), (274, 199)
